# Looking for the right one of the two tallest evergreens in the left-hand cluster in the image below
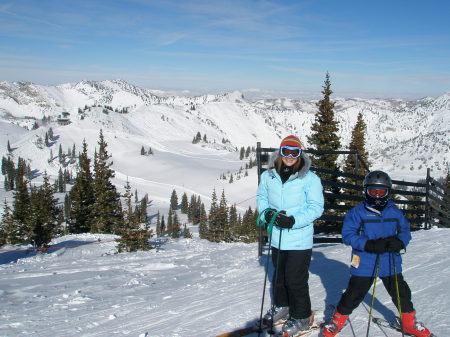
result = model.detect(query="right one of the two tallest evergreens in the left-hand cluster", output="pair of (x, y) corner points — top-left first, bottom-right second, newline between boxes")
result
(91, 130), (123, 234)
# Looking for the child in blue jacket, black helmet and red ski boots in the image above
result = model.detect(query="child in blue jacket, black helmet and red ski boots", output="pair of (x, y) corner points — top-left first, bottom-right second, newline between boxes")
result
(322, 171), (433, 337)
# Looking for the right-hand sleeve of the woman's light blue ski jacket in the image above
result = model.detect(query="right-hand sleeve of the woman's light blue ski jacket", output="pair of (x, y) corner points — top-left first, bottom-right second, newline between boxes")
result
(293, 175), (324, 228)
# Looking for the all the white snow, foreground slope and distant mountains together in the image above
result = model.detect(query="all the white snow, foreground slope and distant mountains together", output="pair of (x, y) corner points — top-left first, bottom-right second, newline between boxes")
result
(0, 80), (450, 337)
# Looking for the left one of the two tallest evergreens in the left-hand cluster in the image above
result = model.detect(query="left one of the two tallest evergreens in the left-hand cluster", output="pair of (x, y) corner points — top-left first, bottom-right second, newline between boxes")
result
(68, 140), (95, 233)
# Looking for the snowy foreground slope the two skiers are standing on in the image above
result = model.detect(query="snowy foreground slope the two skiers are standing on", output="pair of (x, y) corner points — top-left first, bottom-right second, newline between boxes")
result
(0, 229), (450, 337)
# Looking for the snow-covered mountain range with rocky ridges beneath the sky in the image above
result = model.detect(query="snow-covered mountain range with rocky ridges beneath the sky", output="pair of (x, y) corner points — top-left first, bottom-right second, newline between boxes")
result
(0, 80), (450, 213)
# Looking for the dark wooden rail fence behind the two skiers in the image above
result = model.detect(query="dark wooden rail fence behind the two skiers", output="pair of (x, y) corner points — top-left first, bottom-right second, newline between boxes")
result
(256, 142), (450, 255)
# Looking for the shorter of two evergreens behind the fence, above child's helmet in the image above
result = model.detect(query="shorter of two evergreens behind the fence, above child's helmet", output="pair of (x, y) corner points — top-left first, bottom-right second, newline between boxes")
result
(344, 112), (369, 206)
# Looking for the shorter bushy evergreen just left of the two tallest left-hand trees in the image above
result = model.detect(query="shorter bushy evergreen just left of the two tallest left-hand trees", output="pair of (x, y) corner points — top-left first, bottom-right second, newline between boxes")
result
(29, 172), (60, 248)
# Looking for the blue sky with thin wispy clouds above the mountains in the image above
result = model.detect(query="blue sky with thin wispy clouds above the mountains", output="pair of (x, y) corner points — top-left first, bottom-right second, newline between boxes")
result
(0, 0), (450, 99)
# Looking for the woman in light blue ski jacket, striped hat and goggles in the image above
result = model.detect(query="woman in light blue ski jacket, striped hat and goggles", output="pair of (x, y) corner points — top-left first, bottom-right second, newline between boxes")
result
(257, 136), (324, 336)
